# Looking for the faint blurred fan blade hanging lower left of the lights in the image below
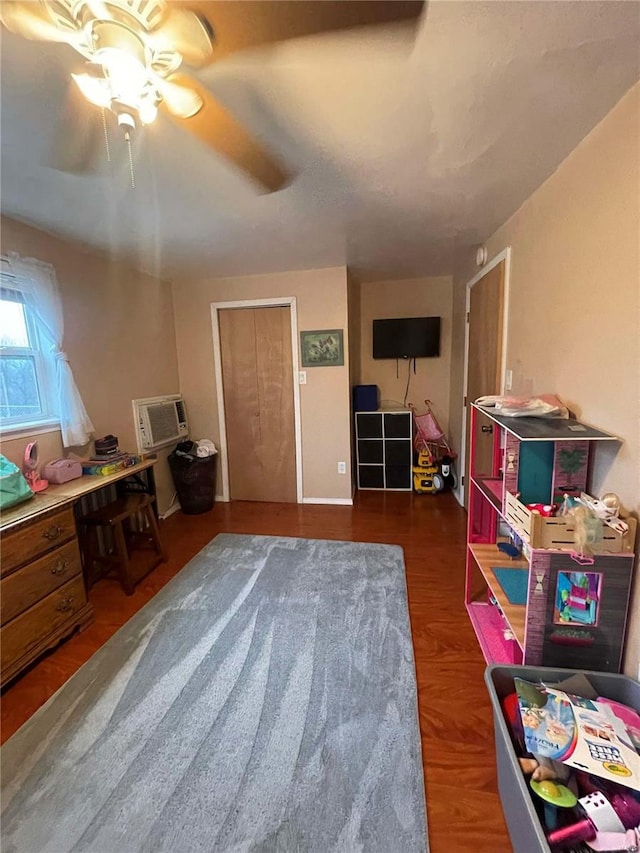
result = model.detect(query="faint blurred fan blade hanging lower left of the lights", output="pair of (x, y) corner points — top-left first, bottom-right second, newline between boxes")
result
(47, 83), (107, 174)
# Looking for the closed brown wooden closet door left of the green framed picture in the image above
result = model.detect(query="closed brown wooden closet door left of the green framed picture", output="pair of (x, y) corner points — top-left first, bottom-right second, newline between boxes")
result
(218, 306), (297, 503)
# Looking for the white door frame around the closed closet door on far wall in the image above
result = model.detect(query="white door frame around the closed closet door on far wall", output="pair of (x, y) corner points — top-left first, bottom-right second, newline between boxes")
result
(211, 296), (302, 503)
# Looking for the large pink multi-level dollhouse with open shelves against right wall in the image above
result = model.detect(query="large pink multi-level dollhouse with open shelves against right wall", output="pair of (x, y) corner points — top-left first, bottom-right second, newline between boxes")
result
(465, 405), (636, 672)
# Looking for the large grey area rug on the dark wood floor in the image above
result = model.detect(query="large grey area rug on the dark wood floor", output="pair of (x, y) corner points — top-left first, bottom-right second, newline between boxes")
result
(1, 534), (428, 853)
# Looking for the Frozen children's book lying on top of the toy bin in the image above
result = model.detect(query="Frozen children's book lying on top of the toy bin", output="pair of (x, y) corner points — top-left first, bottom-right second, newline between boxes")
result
(514, 678), (640, 791)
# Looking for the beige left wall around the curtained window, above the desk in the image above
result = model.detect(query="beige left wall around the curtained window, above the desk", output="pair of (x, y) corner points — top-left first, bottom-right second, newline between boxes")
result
(2, 217), (179, 513)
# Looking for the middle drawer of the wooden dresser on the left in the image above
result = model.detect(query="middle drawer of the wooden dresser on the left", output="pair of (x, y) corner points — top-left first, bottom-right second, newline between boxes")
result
(0, 539), (82, 625)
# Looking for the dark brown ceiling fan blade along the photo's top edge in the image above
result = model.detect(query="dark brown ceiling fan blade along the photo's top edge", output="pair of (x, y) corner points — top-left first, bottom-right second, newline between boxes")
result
(179, 0), (425, 61)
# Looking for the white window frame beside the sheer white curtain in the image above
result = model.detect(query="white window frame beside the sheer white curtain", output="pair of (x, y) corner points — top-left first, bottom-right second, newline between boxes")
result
(0, 282), (60, 438)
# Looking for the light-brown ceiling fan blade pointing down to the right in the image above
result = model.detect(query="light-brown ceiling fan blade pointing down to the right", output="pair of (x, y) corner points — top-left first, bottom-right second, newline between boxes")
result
(161, 76), (292, 192)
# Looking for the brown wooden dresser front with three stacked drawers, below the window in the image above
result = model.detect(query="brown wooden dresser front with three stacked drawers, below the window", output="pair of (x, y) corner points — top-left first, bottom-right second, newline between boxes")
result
(0, 504), (93, 684)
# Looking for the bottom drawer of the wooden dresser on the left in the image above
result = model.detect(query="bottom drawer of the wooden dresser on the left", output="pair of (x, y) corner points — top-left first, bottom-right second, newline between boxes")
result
(0, 575), (87, 672)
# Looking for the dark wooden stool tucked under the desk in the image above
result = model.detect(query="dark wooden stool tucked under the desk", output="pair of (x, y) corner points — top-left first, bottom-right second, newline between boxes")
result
(80, 494), (167, 595)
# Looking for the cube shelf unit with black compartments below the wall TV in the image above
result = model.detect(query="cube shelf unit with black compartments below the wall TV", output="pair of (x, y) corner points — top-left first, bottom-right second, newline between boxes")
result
(355, 409), (413, 492)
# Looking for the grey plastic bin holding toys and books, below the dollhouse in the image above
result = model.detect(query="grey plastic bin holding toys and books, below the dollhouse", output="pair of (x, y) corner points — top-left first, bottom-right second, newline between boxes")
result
(485, 666), (640, 853)
